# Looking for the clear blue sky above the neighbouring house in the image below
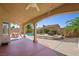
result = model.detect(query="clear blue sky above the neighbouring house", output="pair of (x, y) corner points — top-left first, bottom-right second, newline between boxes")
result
(37, 13), (79, 27)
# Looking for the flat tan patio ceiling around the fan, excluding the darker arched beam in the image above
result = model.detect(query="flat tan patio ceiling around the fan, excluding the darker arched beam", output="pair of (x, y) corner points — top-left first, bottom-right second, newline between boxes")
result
(0, 3), (62, 24)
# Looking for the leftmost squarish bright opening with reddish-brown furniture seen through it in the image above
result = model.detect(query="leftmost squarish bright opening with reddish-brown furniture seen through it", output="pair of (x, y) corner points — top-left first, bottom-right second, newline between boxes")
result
(9, 23), (21, 40)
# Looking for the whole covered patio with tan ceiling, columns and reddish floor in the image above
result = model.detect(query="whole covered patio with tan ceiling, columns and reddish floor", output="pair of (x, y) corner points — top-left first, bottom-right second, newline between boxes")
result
(0, 3), (79, 56)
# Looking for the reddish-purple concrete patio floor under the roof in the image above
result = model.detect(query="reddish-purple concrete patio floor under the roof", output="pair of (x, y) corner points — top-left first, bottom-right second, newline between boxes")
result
(0, 39), (65, 56)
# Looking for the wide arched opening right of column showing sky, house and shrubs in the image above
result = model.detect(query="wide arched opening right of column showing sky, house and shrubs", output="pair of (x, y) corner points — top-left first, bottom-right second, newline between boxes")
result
(37, 12), (79, 39)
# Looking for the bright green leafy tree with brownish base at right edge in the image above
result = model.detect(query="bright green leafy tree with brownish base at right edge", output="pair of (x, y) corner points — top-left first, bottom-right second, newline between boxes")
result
(65, 17), (79, 35)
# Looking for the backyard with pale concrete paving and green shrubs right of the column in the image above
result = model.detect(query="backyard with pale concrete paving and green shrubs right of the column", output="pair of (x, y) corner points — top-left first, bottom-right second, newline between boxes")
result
(25, 17), (79, 56)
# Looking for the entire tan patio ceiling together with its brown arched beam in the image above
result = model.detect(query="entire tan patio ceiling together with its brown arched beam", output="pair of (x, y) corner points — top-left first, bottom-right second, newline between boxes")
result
(0, 3), (79, 25)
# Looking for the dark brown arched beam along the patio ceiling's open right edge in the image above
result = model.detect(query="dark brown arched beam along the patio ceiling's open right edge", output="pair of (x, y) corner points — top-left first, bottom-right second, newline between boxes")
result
(23, 3), (79, 25)
